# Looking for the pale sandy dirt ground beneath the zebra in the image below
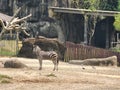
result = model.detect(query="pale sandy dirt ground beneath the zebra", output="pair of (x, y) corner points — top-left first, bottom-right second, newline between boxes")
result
(0, 57), (120, 90)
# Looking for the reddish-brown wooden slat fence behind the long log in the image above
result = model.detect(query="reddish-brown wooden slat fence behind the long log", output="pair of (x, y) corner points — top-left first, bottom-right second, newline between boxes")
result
(64, 42), (120, 62)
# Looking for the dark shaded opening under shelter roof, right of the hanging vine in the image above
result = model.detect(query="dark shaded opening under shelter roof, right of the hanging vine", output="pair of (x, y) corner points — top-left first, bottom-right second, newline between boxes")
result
(94, 17), (115, 48)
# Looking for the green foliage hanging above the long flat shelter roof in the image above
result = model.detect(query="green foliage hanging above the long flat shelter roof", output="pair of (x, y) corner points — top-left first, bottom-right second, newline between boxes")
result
(74, 0), (120, 11)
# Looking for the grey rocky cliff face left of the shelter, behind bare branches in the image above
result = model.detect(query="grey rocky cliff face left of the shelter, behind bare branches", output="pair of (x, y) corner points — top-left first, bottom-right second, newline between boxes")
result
(0, 0), (64, 41)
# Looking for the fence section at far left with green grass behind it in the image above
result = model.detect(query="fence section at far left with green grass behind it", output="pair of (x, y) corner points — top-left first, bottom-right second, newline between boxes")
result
(0, 34), (22, 56)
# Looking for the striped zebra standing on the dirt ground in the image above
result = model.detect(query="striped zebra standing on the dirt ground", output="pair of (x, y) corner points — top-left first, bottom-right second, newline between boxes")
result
(33, 45), (59, 71)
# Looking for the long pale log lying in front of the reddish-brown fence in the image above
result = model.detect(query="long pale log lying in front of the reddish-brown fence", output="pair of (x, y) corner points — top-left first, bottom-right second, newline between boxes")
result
(69, 56), (118, 66)
